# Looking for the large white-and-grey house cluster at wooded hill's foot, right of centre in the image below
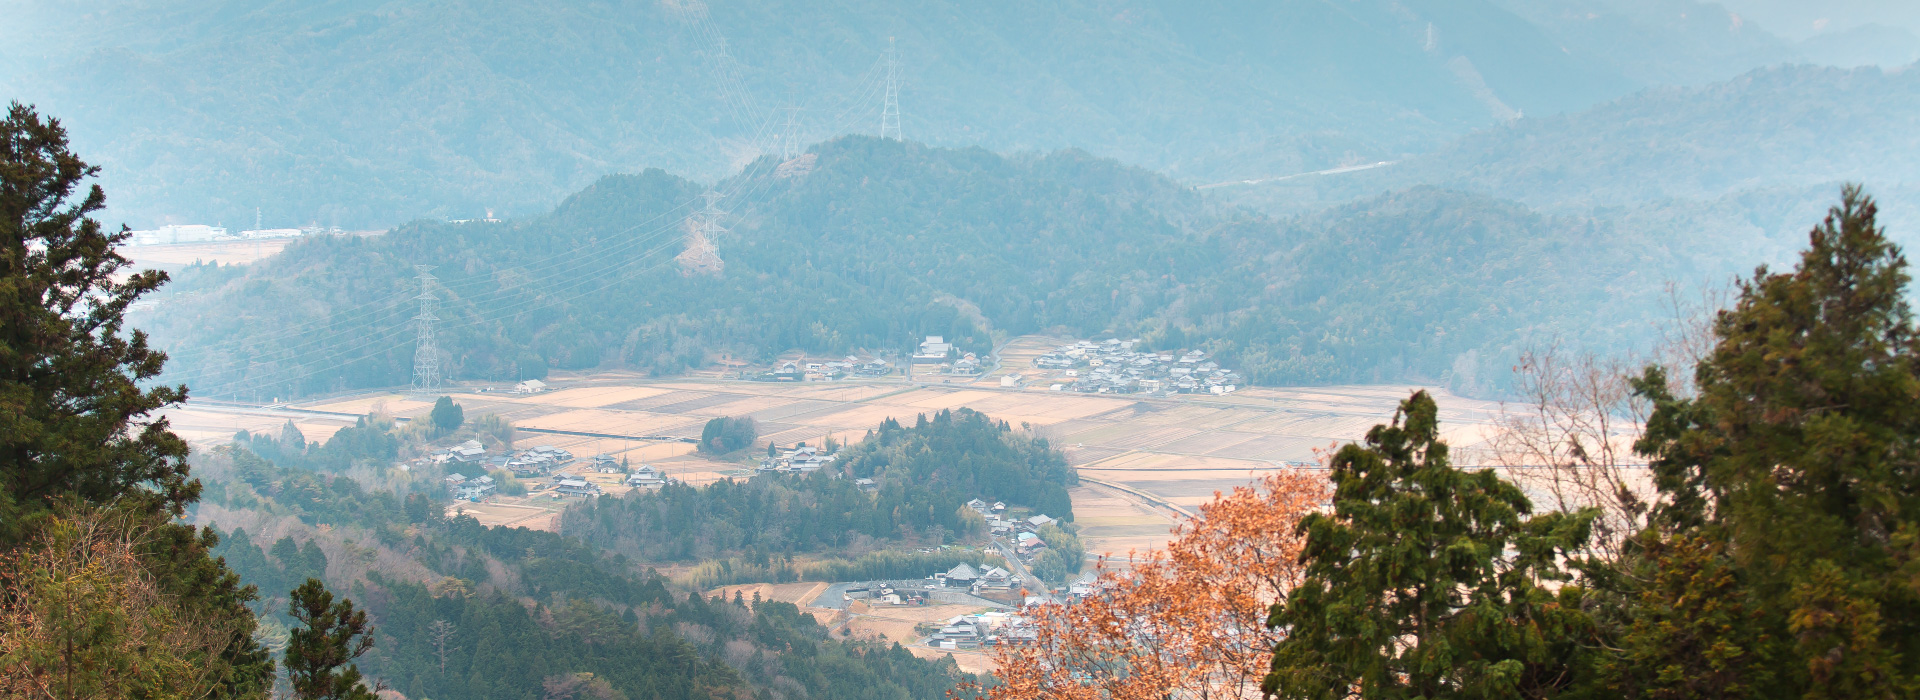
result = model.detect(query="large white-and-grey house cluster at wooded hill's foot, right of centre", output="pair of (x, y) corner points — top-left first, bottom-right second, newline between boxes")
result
(1033, 338), (1244, 393)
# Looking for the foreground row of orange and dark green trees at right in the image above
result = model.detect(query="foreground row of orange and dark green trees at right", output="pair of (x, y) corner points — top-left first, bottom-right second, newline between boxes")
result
(977, 186), (1920, 698)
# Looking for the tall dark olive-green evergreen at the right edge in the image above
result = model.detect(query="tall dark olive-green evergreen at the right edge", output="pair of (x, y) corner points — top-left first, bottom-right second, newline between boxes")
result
(1620, 188), (1920, 698)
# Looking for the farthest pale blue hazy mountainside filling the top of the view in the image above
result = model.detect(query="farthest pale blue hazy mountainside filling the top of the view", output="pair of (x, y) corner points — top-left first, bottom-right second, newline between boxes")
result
(0, 0), (1795, 228)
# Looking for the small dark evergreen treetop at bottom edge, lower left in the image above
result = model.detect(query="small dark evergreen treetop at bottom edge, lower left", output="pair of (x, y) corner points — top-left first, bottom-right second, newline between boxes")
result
(286, 579), (376, 700)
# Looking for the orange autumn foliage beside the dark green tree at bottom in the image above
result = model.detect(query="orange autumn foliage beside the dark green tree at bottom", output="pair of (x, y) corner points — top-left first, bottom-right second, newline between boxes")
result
(968, 470), (1329, 700)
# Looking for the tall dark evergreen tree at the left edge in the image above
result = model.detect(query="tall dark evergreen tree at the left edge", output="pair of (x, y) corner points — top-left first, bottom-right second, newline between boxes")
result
(0, 104), (273, 698)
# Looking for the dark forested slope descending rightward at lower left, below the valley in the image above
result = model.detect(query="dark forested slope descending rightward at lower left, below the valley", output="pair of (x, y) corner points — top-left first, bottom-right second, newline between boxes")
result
(192, 449), (972, 700)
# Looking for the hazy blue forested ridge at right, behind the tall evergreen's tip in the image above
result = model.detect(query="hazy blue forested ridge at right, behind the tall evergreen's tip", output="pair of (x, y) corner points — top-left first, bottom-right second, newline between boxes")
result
(1235, 65), (1920, 219)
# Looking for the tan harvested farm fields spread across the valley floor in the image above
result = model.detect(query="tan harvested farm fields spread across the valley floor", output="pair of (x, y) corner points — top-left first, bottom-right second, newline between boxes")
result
(169, 339), (1498, 556)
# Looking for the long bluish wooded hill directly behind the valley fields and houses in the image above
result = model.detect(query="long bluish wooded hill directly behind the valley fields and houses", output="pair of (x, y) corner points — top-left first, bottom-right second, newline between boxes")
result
(136, 138), (1728, 397)
